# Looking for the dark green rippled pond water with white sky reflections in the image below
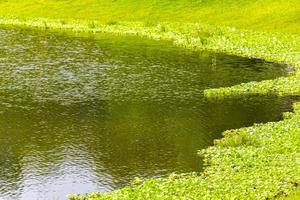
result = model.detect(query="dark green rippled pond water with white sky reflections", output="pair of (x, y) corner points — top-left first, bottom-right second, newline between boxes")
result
(0, 28), (292, 200)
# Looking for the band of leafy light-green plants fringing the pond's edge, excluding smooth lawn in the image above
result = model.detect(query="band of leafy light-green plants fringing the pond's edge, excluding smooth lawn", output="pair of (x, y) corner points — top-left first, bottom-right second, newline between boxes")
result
(0, 17), (300, 199)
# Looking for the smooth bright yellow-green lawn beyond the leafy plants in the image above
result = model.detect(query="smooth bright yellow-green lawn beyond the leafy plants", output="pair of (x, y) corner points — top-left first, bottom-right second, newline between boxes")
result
(0, 0), (300, 33)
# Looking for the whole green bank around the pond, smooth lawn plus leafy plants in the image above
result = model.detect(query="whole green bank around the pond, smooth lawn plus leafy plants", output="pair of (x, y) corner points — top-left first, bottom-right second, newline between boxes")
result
(0, 0), (300, 199)
